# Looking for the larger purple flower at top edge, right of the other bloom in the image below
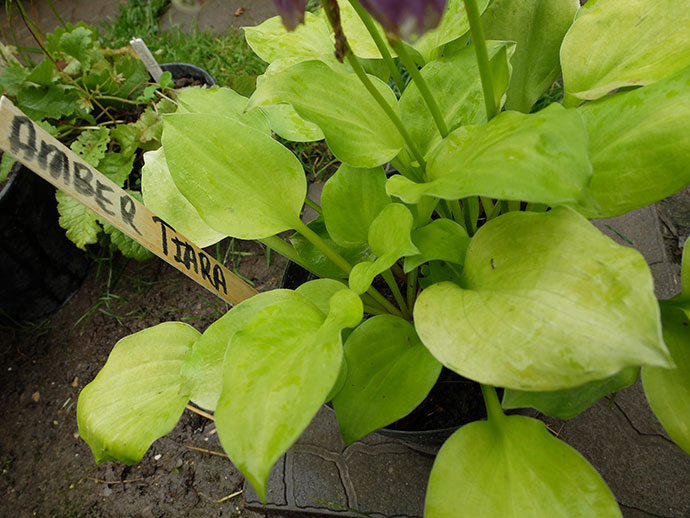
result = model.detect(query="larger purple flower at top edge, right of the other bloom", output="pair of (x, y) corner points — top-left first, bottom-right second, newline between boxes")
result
(360, 0), (447, 41)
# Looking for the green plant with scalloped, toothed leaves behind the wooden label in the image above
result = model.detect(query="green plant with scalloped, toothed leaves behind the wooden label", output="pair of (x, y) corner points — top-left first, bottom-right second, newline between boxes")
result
(0, 18), (175, 260)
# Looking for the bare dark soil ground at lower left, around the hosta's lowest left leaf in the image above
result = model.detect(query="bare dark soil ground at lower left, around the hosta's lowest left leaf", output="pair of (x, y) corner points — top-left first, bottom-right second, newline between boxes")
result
(0, 240), (285, 518)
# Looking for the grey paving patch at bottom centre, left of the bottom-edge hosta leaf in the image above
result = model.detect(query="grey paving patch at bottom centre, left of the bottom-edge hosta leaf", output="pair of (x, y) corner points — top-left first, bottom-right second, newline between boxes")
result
(245, 407), (436, 518)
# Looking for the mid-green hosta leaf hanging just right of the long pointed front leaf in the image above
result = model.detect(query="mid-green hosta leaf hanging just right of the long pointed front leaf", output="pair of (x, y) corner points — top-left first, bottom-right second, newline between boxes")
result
(333, 315), (441, 444)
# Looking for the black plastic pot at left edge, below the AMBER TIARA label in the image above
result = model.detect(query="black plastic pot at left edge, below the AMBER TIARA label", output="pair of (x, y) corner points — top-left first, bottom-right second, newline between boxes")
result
(0, 164), (89, 320)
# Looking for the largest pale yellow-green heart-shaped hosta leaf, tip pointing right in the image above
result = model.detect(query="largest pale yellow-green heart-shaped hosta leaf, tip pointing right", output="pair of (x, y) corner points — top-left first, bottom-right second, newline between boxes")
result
(414, 207), (672, 391)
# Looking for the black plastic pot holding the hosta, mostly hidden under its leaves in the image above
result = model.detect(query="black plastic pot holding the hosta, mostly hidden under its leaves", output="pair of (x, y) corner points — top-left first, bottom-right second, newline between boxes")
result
(280, 262), (486, 448)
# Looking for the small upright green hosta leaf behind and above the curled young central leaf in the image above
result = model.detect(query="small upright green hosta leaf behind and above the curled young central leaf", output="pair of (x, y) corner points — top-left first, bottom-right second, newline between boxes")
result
(321, 164), (391, 246)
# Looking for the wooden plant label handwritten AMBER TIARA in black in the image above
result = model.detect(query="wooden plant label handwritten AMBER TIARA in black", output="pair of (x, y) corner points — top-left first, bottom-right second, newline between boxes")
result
(0, 96), (257, 304)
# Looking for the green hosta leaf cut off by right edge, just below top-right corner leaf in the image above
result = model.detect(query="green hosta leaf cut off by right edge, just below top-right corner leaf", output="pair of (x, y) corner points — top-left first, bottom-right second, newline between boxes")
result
(578, 65), (690, 217)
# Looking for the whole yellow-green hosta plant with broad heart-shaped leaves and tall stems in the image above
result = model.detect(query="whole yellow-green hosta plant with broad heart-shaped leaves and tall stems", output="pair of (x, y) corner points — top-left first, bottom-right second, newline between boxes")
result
(78, 0), (690, 517)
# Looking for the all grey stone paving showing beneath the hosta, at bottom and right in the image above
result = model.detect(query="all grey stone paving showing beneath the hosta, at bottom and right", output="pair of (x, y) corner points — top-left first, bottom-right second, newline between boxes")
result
(245, 207), (690, 518)
